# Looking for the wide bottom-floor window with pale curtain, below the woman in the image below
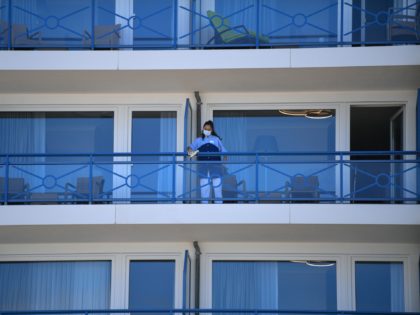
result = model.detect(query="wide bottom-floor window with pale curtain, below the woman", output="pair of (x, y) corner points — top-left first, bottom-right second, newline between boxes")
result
(212, 261), (337, 311)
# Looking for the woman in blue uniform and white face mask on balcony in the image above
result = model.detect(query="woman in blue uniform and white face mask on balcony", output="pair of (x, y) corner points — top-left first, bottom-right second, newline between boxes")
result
(188, 120), (227, 203)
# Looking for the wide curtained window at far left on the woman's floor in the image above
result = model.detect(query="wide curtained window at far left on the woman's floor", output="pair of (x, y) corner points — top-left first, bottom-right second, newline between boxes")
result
(0, 111), (114, 200)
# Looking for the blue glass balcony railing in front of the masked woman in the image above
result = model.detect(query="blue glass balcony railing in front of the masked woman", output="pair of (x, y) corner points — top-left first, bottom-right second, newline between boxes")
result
(0, 151), (420, 205)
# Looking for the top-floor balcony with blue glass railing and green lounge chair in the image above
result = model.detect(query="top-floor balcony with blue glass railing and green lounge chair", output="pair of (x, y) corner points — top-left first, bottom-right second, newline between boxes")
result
(0, 0), (420, 50)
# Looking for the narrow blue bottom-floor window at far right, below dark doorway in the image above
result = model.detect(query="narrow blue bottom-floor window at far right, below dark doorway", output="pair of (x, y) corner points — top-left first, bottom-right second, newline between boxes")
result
(355, 261), (404, 312)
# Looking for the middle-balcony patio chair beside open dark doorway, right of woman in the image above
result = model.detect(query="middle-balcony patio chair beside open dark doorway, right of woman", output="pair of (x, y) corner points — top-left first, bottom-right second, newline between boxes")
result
(286, 175), (320, 202)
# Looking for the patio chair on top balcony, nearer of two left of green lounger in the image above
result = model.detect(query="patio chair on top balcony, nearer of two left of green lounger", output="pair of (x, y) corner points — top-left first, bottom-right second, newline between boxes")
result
(84, 24), (121, 49)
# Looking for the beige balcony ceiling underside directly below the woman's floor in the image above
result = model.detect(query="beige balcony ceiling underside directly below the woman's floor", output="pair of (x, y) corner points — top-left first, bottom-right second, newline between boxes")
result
(0, 224), (420, 244)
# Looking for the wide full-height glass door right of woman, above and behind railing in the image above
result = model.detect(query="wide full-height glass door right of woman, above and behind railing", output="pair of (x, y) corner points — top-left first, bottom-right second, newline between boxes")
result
(213, 109), (336, 200)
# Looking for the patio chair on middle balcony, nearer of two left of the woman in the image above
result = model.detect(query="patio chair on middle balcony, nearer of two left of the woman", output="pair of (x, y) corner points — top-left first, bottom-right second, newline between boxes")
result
(64, 176), (105, 202)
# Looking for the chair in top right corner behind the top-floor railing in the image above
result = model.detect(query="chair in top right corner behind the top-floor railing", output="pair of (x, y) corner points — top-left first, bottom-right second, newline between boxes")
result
(388, 4), (420, 41)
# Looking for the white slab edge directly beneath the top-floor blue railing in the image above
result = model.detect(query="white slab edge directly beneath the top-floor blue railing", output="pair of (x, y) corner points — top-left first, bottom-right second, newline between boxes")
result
(0, 45), (420, 70)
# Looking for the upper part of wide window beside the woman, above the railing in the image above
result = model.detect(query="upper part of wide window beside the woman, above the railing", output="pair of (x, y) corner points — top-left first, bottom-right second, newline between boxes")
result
(214, 110), (335, 152)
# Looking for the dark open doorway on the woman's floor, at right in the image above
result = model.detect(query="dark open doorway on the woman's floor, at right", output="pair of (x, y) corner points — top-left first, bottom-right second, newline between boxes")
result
(350, 106), (404, 203)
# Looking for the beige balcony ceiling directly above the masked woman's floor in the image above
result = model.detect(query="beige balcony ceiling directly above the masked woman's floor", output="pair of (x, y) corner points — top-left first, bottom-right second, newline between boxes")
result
(0, 66), (420, 93)
